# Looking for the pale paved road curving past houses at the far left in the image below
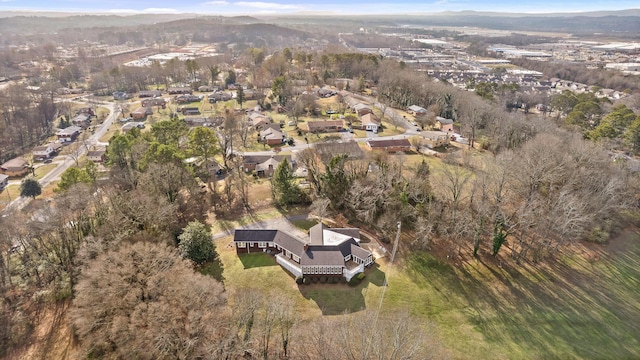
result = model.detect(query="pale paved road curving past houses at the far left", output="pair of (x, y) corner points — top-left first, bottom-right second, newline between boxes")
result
(2, 102), (118, 216)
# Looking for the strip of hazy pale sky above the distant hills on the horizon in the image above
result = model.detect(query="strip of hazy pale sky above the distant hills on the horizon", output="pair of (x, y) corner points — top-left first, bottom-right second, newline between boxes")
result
(0, 0), (640, 14)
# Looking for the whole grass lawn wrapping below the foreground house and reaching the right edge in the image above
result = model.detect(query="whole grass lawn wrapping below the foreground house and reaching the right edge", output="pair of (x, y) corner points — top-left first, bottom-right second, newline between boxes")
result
(217, 224), (640, 359)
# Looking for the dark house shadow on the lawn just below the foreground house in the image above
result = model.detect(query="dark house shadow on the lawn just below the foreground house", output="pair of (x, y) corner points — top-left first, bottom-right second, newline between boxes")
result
(298, 264), (385, 315)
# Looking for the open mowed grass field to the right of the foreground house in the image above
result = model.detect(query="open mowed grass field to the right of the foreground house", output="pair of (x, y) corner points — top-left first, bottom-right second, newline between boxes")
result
(385, 233), (640, 359)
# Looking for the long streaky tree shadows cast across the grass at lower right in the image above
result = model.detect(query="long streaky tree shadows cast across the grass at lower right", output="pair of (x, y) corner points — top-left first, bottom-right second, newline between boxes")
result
(407, 236), (640, 359)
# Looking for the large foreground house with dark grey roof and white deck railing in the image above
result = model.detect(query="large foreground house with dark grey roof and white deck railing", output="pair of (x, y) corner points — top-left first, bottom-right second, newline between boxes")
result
(233, 223), (374, 281)
